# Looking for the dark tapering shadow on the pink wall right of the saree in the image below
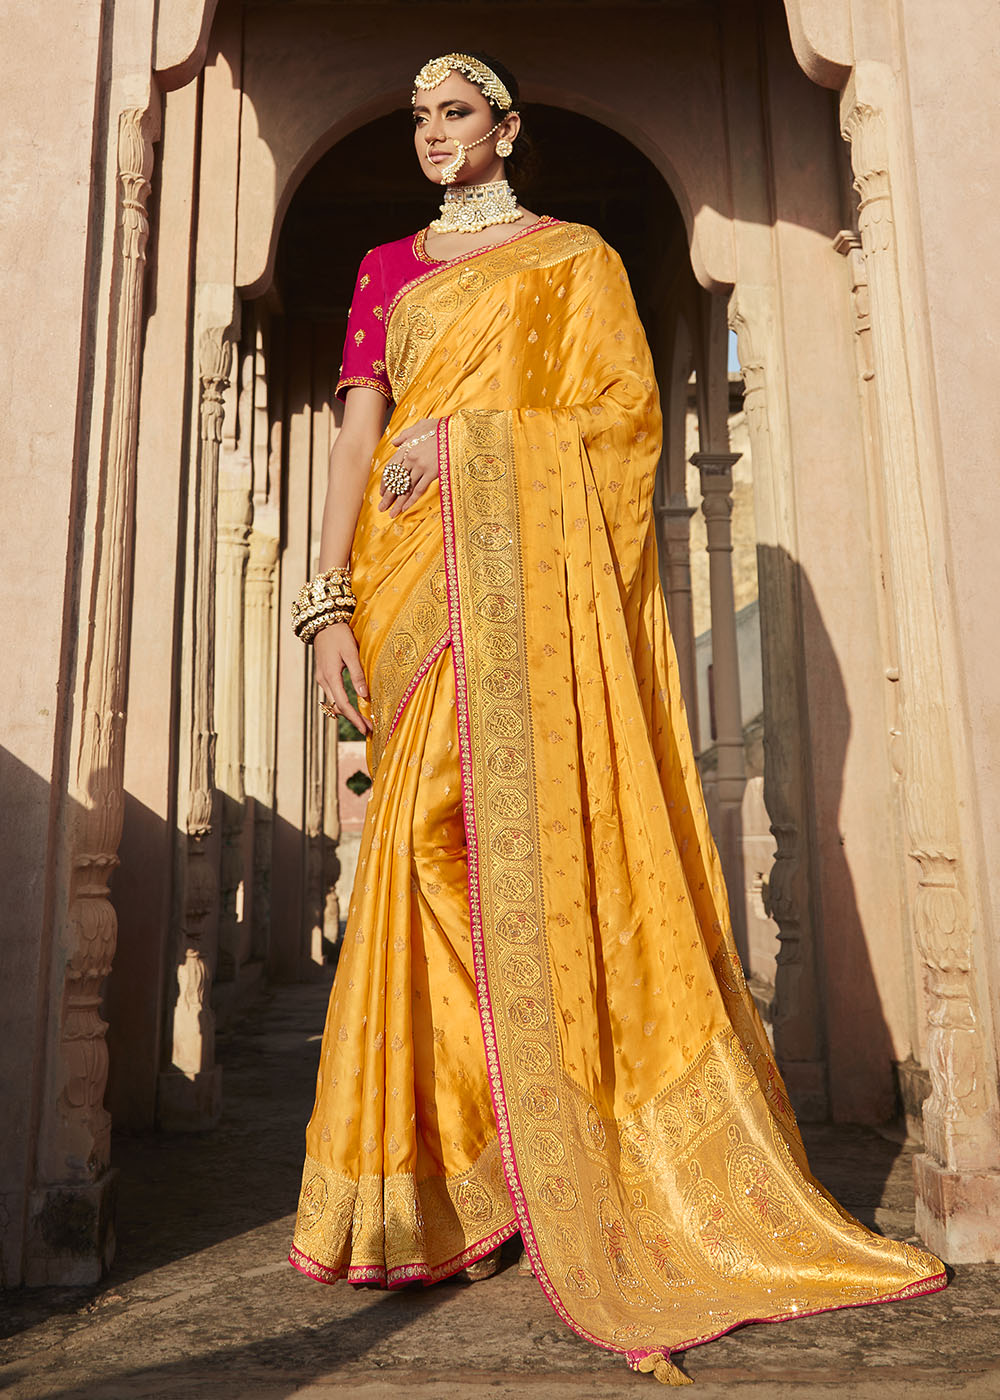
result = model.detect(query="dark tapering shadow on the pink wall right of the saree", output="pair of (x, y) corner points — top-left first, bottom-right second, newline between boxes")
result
(742, 545), (902, 1124)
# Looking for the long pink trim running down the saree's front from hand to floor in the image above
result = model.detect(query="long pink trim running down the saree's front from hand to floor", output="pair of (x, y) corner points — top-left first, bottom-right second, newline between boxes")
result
(437, 408), (626, 1355)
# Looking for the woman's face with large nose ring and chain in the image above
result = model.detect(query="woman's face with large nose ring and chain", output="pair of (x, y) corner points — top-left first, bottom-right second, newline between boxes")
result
(413, 73), (521, 185)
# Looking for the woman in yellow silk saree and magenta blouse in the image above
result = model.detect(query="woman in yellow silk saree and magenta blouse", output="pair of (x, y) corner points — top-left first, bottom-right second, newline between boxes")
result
(291, 55), (945, 1385)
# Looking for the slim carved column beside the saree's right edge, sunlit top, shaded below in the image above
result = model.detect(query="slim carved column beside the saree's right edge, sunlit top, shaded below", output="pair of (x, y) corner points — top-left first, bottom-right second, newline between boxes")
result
(730, 301), (829, 1121)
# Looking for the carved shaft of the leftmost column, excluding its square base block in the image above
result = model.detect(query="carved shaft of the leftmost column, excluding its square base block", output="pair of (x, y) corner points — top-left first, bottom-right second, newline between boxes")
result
(53, 108), (157, 1183)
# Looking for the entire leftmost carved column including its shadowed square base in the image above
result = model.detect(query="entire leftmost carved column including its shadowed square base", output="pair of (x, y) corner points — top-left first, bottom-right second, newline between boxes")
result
(25, 108), (158, 1285)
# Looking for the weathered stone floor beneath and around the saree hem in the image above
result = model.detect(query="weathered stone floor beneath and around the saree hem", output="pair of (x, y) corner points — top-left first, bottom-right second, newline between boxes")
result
(0, 986), (1000, 1400)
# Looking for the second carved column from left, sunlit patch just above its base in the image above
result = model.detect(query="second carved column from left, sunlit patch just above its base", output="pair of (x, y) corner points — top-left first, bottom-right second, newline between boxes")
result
(160, 326), (232, 1130)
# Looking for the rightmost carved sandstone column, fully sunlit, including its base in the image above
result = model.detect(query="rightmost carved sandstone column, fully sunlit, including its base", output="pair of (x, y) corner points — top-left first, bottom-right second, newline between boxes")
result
(843, 91), (1000, 1261)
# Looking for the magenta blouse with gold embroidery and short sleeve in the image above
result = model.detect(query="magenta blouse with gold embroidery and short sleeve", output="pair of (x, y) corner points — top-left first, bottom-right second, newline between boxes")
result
(336, 230), (437, 402)
